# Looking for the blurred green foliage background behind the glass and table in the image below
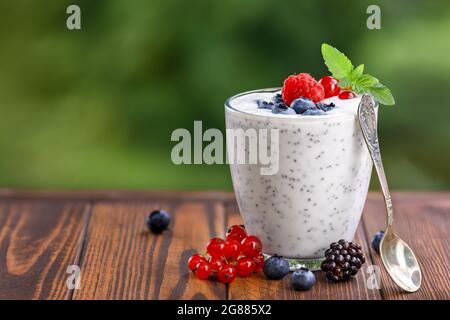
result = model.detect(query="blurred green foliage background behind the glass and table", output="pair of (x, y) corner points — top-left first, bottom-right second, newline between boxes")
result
(0, 0), (450, 189)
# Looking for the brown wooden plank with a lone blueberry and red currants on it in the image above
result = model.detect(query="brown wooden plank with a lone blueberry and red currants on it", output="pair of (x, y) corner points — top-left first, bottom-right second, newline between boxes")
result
(73, 201), (226, 299)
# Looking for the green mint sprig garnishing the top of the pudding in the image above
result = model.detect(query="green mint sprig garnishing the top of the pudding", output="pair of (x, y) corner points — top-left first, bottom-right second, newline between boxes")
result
(322, 43), (395, 106)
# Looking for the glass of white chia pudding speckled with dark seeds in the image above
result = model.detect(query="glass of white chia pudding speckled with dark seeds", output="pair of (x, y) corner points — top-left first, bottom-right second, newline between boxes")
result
(225, 88), (372, 269)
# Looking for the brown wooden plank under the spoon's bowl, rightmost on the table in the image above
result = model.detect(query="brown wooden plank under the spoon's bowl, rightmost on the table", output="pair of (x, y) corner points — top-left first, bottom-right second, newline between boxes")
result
(363, 193), (450, 300)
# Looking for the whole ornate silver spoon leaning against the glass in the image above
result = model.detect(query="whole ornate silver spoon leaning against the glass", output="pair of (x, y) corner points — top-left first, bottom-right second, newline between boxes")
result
(358, 94), (422, 292)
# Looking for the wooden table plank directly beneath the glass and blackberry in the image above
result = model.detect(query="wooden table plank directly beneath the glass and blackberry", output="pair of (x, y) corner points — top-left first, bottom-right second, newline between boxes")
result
(226, 202), (381, 300)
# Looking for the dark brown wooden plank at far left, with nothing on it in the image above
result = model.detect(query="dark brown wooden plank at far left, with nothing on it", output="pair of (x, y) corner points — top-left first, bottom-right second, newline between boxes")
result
(0, 200), (88, 299)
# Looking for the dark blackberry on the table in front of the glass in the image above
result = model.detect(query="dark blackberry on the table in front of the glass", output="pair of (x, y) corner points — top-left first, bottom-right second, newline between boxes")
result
(320, 239), (366, 282)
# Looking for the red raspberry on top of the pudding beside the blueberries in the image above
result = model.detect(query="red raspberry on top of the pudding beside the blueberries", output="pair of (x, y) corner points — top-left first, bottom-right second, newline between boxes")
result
(281, 73), (325, 105)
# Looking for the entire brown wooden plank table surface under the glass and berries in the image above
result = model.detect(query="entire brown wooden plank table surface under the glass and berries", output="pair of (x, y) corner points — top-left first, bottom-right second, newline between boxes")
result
(0, 189), (450, 300)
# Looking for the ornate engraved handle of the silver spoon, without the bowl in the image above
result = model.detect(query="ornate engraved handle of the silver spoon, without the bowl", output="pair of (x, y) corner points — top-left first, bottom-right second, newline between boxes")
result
(358, 94), (394, 227)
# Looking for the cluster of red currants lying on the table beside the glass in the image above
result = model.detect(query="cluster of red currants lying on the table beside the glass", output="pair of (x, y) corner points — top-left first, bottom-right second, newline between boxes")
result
(188, 225), (264, 283)
